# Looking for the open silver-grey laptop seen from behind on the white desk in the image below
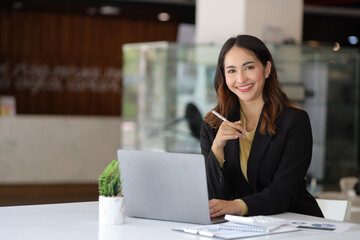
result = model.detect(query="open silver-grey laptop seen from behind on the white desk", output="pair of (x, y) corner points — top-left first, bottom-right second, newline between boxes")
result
(117, 150), (225, 224)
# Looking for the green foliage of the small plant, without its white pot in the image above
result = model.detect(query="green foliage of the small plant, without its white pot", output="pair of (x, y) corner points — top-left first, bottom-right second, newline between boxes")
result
(98, 160), (122, 196)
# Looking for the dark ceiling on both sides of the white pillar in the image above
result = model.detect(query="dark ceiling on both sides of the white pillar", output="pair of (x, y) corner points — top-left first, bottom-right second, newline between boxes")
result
(0, 0), (360, 46)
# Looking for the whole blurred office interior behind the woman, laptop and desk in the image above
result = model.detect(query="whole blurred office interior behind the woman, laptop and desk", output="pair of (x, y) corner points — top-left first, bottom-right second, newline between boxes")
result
(0, 0), (360, 206)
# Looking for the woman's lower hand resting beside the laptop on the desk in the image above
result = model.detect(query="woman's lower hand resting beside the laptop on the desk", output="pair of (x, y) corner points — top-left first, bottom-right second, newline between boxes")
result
(209, 199), (242, 217)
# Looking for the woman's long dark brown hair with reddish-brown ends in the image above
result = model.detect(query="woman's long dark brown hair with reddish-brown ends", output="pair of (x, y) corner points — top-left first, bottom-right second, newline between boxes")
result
(205, 35), (297, 134)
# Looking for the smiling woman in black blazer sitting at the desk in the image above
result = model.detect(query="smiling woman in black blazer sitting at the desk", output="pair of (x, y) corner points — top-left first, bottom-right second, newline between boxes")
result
(200, 35), (323, 217)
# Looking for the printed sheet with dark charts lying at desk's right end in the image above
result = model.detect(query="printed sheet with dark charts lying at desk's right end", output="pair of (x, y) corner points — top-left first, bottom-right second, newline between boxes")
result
(291, 220), (354, 233)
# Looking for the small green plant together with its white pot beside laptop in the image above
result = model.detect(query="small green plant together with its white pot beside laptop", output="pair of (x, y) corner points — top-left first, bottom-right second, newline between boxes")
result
(98, 160), (125, 224)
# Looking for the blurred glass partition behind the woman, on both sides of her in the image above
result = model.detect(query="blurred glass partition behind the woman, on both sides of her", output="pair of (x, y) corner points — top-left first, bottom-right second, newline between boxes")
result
(122, 42), (359, 188)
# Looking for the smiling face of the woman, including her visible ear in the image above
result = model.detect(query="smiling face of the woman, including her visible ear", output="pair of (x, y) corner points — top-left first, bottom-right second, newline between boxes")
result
(224, 46), (271, 104)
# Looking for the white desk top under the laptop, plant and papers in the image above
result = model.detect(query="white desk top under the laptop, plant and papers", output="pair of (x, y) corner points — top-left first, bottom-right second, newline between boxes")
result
(0, 202), (360, 240)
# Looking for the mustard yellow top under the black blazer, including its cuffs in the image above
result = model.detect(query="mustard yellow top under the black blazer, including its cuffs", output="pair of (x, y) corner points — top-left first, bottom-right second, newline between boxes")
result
(215, 112), (256, 215)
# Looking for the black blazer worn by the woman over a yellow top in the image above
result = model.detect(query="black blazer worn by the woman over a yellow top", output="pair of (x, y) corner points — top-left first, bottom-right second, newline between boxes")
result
(200, 107), (323, 217)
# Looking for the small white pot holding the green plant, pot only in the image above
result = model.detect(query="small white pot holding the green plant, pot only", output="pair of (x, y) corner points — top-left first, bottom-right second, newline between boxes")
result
(99, 196), (125, 224)
